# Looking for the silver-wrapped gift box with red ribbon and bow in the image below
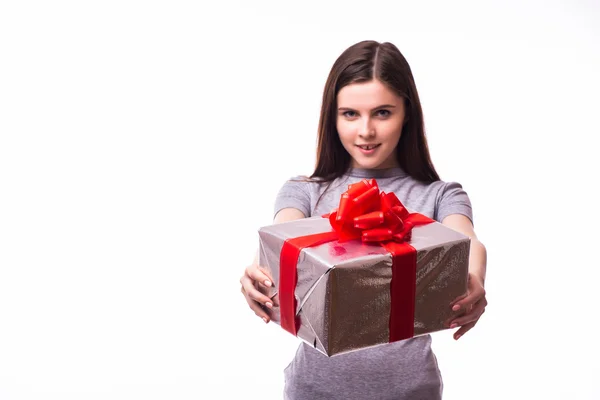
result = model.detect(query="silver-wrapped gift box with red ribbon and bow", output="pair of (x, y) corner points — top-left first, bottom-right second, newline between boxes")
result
(258, 179), (470, 356)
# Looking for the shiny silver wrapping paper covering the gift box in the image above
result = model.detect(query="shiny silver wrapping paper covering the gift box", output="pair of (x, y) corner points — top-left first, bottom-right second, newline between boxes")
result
(259, 217), (470, 356)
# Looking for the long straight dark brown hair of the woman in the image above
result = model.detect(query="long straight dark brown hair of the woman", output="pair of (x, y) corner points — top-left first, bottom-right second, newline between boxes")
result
(309, 40), (440, 182)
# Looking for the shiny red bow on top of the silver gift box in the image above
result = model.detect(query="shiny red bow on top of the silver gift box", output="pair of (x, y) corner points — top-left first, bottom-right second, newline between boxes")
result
(329, 179), (418, 243)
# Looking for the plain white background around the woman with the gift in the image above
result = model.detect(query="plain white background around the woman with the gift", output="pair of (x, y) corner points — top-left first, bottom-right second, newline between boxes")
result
(0, 0), (600, 400)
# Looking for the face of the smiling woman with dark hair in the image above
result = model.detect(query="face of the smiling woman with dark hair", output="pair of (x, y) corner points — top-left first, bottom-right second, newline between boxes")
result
(336, 79), (405, 169)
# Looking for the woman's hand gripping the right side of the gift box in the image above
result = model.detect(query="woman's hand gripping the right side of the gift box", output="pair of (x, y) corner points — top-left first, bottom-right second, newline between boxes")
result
(450, 273), (487, 340)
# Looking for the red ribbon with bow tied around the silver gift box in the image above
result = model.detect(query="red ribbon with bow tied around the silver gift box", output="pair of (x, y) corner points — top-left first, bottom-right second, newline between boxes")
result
(279, 179), (434, 342)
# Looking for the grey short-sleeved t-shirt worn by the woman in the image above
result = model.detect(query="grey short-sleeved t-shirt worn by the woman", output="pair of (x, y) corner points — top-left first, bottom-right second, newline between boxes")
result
(275, 168), (473, 400)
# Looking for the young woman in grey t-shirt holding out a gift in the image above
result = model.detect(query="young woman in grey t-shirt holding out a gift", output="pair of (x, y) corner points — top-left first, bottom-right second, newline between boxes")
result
(240, 41), (487, 400)
